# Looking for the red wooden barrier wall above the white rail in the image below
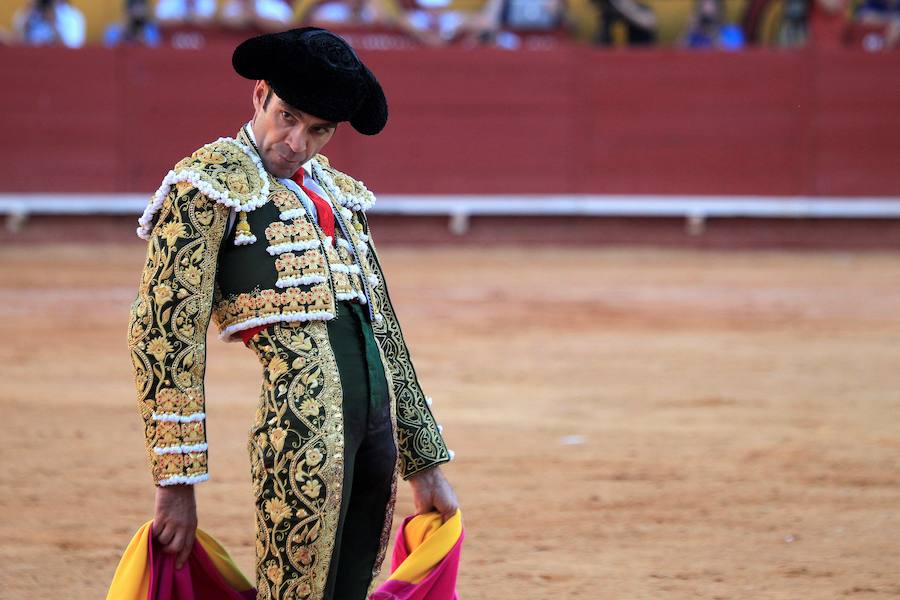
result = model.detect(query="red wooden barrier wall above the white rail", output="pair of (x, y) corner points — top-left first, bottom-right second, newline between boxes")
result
(0, 47), (900, 196)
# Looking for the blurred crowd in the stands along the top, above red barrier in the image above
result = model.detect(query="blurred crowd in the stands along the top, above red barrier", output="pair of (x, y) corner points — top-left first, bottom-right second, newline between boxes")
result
(0, 0), (900, 51)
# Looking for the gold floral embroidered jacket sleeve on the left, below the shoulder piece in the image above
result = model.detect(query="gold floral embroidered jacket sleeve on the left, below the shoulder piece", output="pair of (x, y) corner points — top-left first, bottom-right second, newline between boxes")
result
(128, 183), (230, 485)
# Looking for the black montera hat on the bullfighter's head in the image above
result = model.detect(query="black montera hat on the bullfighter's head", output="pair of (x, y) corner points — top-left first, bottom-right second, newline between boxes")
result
(231, 27), (387, 135)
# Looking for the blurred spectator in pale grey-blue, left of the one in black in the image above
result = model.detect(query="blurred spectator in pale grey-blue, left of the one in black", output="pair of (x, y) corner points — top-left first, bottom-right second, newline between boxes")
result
(461, 0), (567, 49)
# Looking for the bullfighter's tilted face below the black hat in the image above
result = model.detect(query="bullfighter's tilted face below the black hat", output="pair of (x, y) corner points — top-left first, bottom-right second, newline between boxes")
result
(252, 81), (337, 177)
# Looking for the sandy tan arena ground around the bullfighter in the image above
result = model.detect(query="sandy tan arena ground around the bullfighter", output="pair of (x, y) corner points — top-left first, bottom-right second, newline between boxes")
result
(0, 243), (900, 600)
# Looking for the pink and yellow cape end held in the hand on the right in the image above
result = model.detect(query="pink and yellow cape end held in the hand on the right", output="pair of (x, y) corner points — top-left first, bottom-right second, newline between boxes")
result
(369, 510), (465, 600)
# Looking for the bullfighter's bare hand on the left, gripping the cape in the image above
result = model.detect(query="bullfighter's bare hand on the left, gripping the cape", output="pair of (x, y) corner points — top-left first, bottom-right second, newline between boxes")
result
(153, 485), (197, 569)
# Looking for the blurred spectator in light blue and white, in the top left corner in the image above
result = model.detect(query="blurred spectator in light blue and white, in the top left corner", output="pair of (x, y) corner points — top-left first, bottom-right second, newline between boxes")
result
(14, 0), (85, 48)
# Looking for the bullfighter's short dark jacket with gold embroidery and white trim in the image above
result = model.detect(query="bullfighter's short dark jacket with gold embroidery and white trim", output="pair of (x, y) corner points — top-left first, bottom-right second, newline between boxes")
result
(128, 130), (452, 485)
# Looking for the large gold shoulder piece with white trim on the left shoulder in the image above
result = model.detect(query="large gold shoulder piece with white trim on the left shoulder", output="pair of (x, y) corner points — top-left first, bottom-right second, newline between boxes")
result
(137, 138), (269, 240)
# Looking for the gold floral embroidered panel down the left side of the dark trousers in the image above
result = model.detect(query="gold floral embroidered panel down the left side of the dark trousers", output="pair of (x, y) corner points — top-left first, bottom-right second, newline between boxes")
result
(250, 322), (344, 600)
